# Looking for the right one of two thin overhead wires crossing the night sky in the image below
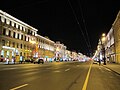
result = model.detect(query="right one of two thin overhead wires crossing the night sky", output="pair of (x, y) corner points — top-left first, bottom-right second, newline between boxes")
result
(78, 0), (92, 53)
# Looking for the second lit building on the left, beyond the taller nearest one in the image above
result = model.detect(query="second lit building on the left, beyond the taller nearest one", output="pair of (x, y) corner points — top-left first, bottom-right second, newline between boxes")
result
(36, 35), (55, 61)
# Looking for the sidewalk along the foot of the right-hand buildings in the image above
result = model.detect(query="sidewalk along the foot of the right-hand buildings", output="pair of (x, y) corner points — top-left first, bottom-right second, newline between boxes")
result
(103, 63), (120, 75)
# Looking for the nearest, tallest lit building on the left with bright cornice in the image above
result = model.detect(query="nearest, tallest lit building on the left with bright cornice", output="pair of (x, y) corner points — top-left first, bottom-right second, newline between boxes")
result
(0, 10), (38, 61)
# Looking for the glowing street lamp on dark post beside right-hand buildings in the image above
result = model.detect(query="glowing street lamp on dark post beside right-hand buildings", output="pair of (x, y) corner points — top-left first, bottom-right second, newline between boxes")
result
(100, 33), (106, 65)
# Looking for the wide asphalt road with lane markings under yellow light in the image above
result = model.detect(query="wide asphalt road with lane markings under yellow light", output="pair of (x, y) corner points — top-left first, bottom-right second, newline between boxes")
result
(0, 62), (120, 90)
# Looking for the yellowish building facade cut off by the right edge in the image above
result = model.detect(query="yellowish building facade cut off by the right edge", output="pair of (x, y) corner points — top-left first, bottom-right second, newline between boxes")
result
(113, 11), (120, 63)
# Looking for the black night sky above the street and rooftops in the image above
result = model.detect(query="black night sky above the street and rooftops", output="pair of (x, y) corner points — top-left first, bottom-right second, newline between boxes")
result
(0, 0), (120, 55)
